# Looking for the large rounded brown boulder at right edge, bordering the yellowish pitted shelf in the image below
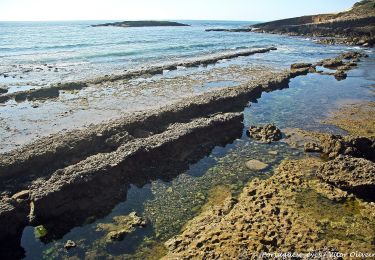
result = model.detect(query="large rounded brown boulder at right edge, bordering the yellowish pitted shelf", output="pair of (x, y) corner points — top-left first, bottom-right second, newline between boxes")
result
(317, 155), (375, 200)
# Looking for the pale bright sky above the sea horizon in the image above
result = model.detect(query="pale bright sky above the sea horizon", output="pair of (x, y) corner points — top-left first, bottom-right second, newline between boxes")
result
(0, 0), (357, 21)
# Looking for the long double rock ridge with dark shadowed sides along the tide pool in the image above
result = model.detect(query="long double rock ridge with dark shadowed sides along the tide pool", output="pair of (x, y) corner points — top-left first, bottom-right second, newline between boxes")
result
(0, 50), (370, 254)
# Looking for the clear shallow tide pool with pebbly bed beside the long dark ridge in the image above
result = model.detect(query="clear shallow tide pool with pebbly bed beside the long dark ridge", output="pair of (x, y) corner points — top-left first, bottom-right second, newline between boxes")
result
(21, 53), (375, 259)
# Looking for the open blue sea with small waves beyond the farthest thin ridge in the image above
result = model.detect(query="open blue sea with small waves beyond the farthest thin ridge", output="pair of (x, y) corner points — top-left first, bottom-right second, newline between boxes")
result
(0, 21), (362, 86)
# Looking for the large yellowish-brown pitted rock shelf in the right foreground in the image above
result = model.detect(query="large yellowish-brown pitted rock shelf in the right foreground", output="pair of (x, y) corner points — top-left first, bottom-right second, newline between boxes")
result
(165, 158), (375, 259)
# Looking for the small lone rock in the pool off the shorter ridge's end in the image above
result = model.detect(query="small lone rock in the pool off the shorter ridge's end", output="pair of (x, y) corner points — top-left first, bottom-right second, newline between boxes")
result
(247, 124), (282, 143)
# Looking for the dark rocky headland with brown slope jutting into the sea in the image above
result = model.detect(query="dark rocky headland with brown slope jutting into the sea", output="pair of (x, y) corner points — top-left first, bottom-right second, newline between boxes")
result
(206, 0), (375, 47)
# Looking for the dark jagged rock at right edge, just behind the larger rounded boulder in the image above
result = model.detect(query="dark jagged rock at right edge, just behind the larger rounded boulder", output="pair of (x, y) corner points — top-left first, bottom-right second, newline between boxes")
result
(321, 135), (375, 161)
